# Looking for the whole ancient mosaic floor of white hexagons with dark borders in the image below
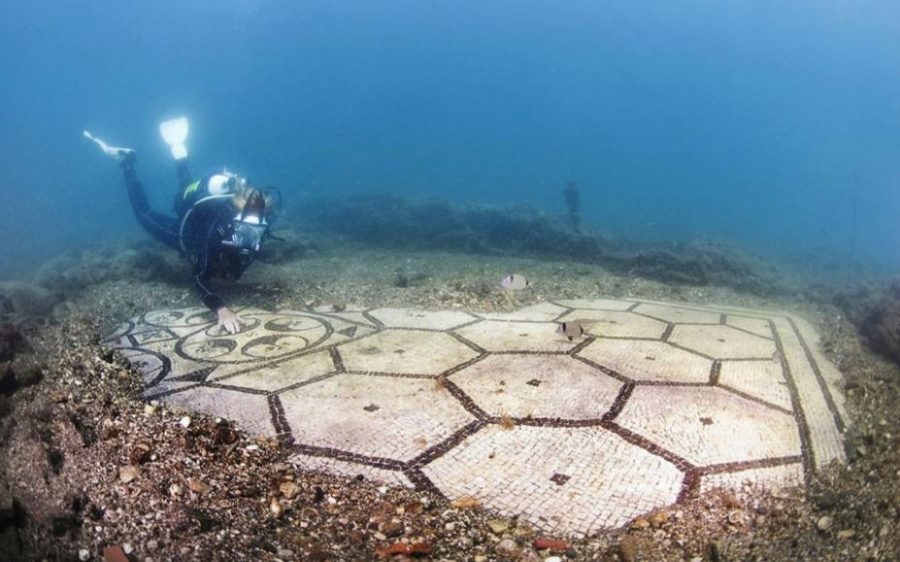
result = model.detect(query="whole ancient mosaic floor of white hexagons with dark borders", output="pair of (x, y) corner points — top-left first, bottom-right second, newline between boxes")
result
(106, 299), (847, 535)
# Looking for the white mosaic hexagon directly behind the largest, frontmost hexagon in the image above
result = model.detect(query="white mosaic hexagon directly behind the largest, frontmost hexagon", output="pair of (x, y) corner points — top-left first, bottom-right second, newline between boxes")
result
(450, 355), (622, 420)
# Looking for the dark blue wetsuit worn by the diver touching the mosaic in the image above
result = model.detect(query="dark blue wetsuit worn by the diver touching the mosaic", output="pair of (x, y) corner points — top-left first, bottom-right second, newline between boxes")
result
(121, 153), (256, 312)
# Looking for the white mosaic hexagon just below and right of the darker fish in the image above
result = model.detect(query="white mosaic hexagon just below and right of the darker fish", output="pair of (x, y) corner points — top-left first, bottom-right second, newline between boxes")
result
(578, 338), (713, 383)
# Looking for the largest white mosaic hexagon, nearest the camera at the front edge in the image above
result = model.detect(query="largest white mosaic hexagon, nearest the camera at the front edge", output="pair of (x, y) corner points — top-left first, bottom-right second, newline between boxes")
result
(423, 425), (684, 534)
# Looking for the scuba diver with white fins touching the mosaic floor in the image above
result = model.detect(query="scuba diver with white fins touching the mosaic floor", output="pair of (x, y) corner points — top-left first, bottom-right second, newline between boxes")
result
(84, 117), (271, 334)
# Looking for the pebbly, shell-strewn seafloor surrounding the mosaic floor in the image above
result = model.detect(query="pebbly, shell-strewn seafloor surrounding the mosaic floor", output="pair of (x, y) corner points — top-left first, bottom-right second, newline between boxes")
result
(0, 242), (900, 561)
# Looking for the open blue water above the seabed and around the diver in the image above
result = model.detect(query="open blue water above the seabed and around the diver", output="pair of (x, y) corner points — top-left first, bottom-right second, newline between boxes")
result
(0, 0), (900, 278)
